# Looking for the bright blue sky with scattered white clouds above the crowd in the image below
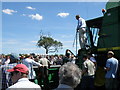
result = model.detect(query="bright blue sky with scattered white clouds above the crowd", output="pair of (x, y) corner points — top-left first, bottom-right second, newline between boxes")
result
(0, 2), (106, 54)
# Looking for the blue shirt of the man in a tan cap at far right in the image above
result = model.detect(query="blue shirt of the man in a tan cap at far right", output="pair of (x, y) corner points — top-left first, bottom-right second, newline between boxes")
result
(105, 57), (118, 78)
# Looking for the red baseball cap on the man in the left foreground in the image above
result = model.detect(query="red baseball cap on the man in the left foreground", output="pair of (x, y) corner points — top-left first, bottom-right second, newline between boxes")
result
(7, 64), (28, 73)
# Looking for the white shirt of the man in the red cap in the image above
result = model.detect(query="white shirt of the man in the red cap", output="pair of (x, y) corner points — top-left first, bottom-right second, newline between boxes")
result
(6, 78), (41, 90)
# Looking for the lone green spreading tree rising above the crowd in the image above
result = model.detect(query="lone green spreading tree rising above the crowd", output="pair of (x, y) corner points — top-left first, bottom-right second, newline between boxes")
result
(37, 35), (63, 54)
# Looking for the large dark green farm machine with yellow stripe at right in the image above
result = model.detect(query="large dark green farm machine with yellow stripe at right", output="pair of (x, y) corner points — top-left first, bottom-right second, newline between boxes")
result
(76, 0), (120, 86)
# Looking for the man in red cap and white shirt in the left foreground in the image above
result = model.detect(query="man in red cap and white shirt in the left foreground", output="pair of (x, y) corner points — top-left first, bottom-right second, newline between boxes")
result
(7, 64), (41, 90)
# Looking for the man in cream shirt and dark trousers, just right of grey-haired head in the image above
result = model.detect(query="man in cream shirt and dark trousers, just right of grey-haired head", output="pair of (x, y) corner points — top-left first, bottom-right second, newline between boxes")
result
(81, 54), (95, 90)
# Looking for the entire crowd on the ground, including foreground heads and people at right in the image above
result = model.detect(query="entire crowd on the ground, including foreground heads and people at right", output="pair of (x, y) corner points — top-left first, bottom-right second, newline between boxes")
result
(0, 49), (120, 90)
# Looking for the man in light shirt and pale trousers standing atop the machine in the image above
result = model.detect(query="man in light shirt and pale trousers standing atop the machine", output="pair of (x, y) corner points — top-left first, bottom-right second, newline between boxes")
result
(76, 15), (86, 49)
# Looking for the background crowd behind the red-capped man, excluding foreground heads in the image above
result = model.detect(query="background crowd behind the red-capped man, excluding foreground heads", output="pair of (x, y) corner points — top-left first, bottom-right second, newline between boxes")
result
(0, 53), (75, 90)
